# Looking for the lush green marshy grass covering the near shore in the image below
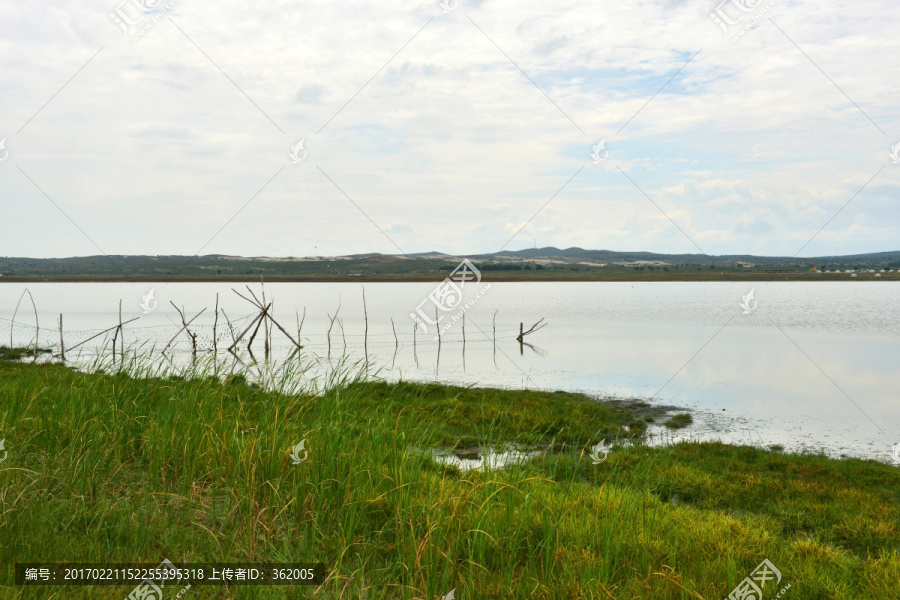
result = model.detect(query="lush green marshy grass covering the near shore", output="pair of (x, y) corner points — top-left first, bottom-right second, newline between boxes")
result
(0, 354), (900, 600)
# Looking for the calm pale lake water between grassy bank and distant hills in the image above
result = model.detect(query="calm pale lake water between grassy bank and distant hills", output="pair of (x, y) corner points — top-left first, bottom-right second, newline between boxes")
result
(0, 281), (900, 461)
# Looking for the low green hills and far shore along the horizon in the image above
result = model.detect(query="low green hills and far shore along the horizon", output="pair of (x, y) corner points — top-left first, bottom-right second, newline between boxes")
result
(0, 247), (900, 281)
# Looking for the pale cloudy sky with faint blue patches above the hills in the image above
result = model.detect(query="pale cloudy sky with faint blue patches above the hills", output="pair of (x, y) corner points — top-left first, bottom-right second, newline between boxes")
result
(0, 0), (900, 257)
